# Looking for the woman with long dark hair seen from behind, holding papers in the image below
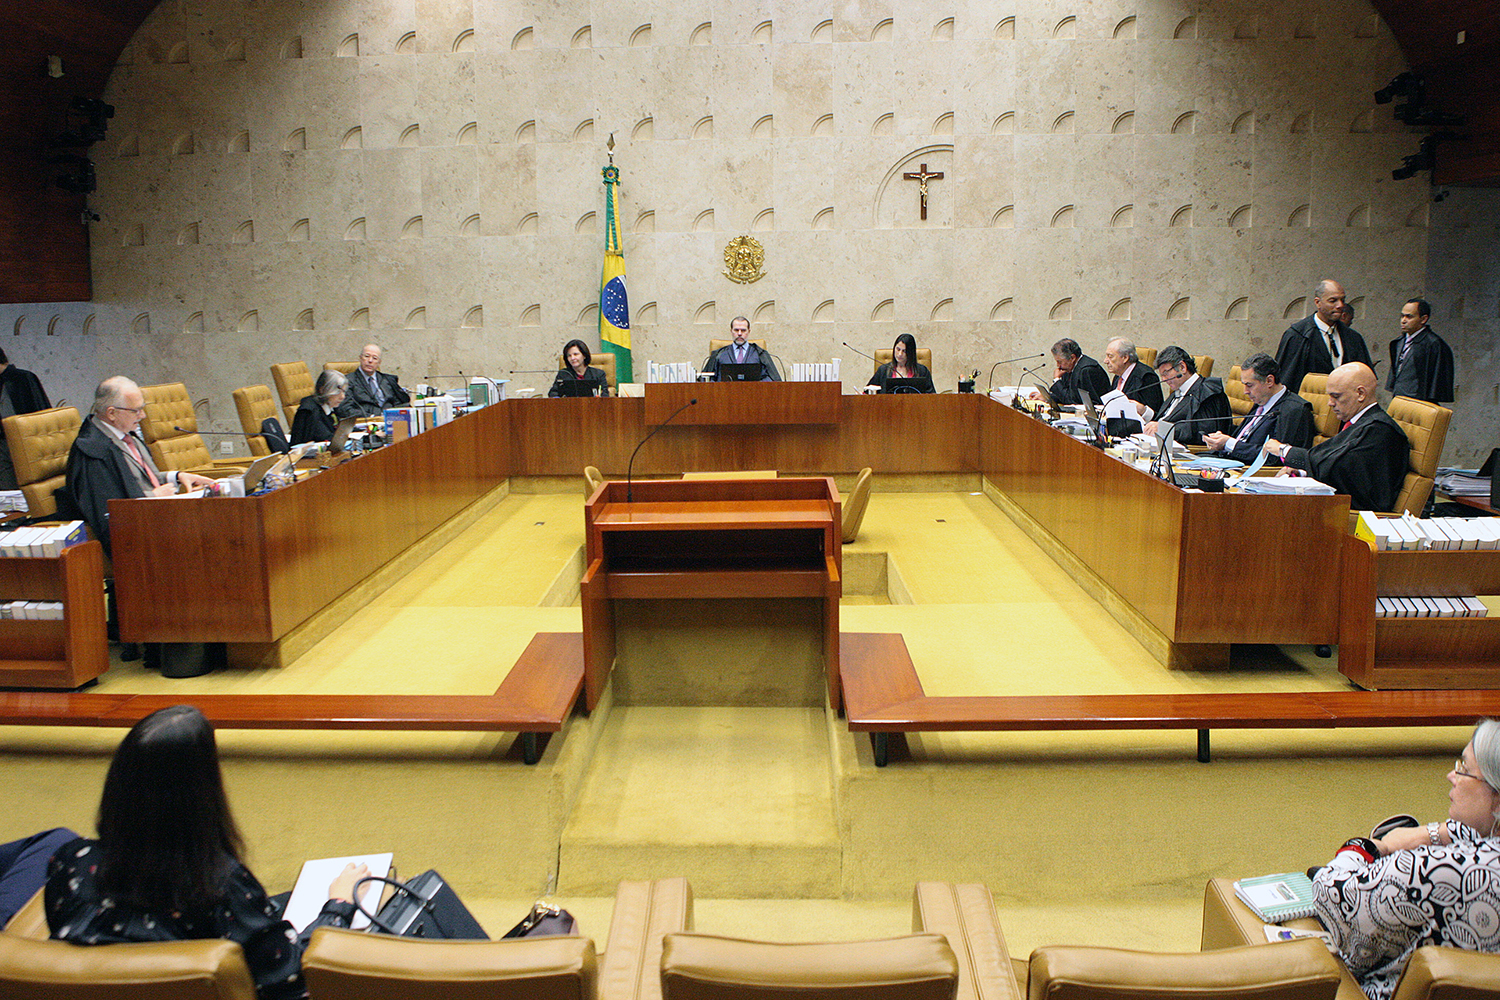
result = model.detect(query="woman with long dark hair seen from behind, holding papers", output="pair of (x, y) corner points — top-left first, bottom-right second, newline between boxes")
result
(45, 705), (369, 1000)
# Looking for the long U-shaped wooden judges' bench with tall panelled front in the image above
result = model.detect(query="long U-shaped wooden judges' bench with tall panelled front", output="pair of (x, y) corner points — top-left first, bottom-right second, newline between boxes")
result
(0, 384), (1470, 761)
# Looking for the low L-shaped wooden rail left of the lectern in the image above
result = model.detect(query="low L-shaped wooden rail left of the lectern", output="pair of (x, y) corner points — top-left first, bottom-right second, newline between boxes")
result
(0, 633), (584, 765)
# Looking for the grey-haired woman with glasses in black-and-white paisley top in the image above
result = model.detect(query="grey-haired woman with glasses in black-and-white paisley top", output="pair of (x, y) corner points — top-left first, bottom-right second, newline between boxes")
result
(1313, 718), (1500, 1000)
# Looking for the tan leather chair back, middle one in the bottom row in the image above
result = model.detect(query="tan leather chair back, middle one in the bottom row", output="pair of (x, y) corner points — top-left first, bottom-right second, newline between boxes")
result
(662, 934), (959, 1000)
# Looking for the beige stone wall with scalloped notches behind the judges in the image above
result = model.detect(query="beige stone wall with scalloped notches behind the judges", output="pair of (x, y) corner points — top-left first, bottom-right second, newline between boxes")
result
(0, 0), (1440, 449)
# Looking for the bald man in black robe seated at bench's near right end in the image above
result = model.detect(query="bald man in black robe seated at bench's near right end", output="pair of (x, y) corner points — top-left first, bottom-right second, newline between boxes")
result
(1262, 363), (1421, 513)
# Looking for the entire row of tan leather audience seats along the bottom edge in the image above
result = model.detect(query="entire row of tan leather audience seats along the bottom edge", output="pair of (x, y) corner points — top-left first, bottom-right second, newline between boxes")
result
(14, 879), (1500, 1000)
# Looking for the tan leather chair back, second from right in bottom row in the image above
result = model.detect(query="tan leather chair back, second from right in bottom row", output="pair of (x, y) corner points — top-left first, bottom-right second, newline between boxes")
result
(1026, 939), (1343, 1000)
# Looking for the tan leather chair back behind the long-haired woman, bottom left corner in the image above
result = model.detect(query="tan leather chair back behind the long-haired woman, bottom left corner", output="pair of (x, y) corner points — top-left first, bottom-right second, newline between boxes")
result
(0, 933), (255, 1000)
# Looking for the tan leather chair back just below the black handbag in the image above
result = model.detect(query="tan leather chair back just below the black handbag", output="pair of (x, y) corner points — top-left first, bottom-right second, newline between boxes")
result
(302, 927), (599, 1000)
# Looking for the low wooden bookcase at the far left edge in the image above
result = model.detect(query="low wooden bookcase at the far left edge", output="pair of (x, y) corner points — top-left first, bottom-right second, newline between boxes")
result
(0, 541), (110, 690)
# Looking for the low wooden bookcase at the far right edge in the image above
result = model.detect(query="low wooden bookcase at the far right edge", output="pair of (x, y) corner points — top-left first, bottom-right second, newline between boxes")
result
(1344, 535), (1500, 690)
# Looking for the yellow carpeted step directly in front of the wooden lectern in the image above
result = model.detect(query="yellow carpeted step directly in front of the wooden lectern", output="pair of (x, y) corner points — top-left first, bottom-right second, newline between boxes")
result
(558, 704), (842, 898)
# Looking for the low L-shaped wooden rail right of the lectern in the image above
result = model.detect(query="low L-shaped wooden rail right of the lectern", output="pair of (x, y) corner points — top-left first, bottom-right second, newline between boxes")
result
(839, 633), (1500, 768)
